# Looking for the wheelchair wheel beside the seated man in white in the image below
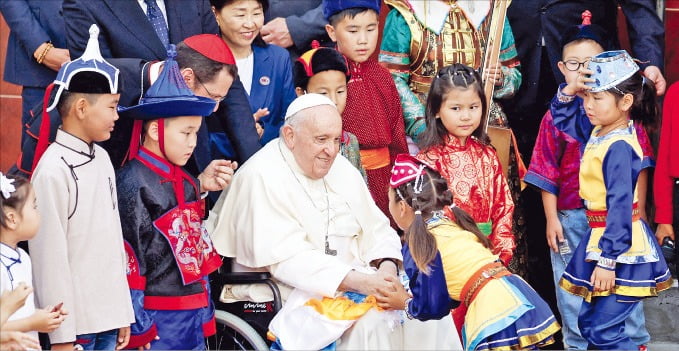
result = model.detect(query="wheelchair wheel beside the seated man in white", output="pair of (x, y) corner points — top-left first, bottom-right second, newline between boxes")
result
(208, 310), (269, 350)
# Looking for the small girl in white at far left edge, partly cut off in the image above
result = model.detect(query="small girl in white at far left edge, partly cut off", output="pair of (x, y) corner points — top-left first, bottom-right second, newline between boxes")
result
(0, 173), (67, 339)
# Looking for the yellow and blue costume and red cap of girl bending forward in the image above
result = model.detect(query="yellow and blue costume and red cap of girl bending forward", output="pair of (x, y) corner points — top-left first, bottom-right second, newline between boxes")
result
(390, 155), (559, 350)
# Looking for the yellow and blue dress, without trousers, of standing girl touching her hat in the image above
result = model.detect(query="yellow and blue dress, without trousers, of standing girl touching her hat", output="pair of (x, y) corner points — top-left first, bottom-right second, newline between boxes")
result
(552, 106), (672, 302)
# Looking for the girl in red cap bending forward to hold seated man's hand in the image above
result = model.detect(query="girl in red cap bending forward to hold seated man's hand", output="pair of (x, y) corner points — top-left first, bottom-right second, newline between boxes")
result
(377, 155), (559, 350)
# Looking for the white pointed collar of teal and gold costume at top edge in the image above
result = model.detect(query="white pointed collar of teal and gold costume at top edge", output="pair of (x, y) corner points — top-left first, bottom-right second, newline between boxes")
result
(408, 0), (490, 35)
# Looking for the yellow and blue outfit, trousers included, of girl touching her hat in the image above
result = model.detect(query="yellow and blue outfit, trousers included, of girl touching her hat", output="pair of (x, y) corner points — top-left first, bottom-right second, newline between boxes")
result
(550, 66), (672, 349)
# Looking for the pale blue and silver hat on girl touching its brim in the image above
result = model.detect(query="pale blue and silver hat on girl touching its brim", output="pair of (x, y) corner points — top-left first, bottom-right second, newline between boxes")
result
(587, 50), (639, 93)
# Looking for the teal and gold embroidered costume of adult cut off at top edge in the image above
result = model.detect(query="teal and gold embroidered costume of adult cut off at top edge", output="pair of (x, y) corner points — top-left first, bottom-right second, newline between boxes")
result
(379, 0), (521, 140)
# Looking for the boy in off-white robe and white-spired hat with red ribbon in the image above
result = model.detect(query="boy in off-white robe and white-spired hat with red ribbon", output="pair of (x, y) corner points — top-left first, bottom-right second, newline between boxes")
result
(28, 25), (134, 350)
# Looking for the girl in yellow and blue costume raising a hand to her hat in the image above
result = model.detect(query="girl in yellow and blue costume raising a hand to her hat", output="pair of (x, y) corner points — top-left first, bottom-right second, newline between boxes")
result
(550, 50), (672, 350)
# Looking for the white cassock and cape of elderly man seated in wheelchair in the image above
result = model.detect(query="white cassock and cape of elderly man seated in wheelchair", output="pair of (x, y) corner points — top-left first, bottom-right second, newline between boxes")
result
(208, 139), (459, 350)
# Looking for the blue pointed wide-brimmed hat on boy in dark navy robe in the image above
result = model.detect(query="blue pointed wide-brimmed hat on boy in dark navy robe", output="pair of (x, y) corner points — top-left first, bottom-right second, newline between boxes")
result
(118, 44), (217, 120)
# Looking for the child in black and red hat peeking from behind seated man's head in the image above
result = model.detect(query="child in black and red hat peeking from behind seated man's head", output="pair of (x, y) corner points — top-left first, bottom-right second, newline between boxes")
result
(292, 40), (368, 183)
